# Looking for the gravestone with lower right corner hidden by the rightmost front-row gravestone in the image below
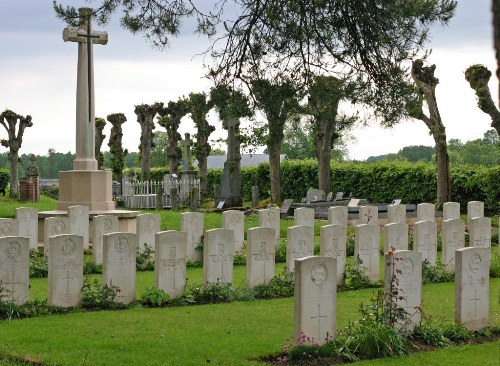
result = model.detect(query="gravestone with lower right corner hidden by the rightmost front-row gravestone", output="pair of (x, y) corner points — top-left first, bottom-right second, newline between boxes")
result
(441, 219), (465, 271)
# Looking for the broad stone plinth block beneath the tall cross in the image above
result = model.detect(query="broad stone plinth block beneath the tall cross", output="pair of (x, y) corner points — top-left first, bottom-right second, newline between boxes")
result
(57, 170), (115, 211)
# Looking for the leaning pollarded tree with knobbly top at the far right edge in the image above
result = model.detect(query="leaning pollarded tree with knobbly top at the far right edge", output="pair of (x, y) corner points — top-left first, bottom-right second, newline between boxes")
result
(465, 65), (500, 135)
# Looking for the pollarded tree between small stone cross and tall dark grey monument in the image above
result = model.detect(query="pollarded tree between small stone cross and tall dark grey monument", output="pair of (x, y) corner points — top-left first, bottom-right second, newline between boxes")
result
(189, 93), (215, 197)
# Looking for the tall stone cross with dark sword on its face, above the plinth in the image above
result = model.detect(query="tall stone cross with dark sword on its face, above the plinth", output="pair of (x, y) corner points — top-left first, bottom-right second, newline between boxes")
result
(63, 8), (108, 170)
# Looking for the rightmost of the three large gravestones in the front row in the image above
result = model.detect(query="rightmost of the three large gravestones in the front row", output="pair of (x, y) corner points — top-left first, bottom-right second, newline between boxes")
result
(455, 248), (490, 330)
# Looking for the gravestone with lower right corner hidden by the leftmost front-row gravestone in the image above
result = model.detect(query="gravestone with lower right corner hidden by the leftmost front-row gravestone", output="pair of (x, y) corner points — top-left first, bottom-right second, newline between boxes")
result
(286, 226), (314, 273)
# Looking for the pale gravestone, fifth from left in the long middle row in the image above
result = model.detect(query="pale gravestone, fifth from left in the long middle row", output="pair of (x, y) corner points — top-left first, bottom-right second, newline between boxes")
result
(203, 229), (234, 283)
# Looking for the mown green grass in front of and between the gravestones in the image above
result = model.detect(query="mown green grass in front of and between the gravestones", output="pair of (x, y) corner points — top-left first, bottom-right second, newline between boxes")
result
(0, 197), (500, 365)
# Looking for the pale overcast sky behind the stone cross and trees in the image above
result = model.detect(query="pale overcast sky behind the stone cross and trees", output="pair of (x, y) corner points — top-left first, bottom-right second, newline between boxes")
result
(0, 0), (498, 160)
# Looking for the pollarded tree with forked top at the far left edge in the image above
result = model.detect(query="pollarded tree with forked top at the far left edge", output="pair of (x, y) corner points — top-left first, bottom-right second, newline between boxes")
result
(0, 109), (33, 197)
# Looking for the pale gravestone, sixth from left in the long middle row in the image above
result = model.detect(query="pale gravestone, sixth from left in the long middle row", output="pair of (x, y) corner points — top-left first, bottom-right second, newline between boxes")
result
(247, 227), (276, 287)
